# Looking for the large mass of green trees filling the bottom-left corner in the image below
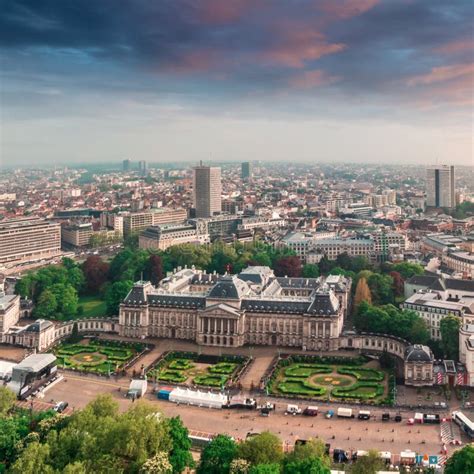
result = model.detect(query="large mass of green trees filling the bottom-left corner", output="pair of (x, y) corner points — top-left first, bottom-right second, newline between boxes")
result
(0, 388), (194, 474)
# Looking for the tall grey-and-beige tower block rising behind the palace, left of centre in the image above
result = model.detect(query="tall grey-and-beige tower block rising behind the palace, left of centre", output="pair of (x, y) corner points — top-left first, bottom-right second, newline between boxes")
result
(193, 163), (222, 218)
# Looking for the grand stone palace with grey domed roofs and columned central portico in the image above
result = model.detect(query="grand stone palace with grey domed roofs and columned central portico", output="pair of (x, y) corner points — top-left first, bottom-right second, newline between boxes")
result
(119, 266), (351, 350)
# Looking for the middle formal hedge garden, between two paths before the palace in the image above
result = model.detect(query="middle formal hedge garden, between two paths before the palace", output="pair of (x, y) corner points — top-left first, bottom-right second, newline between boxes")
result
(147, 352), (249, 388)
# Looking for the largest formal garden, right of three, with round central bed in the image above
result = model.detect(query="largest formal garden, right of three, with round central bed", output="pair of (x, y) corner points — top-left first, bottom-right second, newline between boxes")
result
(265, 356), (395, 405)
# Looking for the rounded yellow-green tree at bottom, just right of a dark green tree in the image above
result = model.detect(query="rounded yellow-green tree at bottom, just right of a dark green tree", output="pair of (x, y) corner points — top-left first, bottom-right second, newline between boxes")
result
(239, 431), (283, 465)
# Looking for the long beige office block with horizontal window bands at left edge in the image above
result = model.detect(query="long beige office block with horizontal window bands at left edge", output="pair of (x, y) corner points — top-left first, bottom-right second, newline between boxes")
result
(0, 217), (61, 264)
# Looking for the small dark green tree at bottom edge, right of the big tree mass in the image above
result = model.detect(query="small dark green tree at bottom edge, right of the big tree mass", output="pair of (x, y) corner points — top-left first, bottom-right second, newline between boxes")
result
(196, 435), (238, 474)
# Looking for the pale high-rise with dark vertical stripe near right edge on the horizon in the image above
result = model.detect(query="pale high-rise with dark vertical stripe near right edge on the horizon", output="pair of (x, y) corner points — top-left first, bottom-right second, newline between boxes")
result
(426, 165), (456, 207)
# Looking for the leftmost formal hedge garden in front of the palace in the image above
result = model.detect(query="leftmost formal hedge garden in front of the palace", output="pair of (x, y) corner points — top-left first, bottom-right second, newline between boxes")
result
(54, 338), (146, 375)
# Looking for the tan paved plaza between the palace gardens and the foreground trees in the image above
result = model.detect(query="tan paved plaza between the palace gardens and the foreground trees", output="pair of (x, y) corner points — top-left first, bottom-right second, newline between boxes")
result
(44, 374), (448, 462)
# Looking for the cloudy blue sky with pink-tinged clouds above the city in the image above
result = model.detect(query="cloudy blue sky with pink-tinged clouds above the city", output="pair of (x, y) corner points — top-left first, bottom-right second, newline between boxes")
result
(0, 0), (474, 167)
